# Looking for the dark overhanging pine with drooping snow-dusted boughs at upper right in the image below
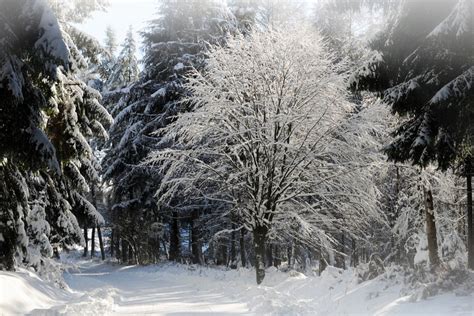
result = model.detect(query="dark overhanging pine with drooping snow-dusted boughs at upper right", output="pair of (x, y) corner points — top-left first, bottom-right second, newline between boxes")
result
(353, 0), (474, 268)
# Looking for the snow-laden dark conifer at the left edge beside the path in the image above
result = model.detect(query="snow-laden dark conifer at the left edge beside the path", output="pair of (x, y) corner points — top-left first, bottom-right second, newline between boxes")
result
(0, 1), (110, 269)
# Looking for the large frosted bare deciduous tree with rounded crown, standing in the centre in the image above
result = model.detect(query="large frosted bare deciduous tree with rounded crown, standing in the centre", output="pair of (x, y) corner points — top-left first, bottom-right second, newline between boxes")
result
(148, 28), (386, 283)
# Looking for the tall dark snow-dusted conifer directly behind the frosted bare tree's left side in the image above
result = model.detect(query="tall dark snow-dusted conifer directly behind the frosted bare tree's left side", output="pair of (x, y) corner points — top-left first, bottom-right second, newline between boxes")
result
(104, 0), (239, 259)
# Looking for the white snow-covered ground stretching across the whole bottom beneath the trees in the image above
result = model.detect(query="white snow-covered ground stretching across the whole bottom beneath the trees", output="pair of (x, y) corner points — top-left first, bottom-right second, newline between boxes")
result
(0, 254), (474, 316)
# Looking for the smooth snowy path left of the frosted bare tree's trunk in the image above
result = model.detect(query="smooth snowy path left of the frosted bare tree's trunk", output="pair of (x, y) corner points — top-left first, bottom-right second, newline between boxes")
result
(33, 263), (249, 315)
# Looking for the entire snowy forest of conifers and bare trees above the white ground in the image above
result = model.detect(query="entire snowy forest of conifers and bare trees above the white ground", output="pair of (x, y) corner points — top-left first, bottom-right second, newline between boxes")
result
(0, 0), (474, 315)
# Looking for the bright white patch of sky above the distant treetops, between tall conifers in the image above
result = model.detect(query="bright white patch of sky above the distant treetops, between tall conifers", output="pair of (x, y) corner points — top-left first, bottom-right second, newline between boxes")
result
(78, 0), (159, 58)
